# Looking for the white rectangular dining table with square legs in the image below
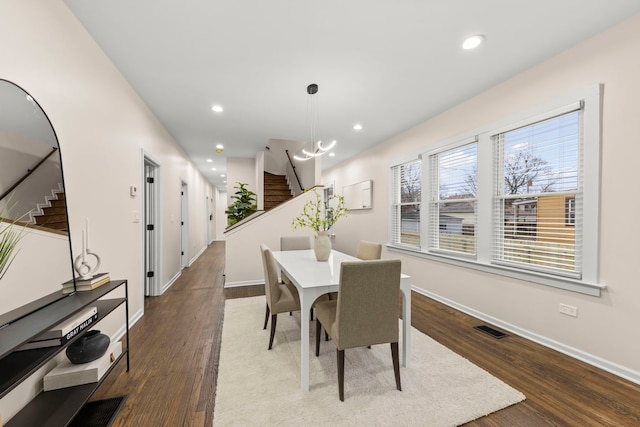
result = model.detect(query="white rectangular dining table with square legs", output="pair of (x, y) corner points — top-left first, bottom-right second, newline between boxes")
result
(273, 250), (411, 391)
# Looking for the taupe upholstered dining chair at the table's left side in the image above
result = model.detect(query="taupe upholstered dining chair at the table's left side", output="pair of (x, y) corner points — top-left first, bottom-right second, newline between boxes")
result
(260, 244), (300, 350)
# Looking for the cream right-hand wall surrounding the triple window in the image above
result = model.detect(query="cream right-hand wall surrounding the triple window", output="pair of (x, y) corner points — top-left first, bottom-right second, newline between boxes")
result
(323, 15), (640, 382)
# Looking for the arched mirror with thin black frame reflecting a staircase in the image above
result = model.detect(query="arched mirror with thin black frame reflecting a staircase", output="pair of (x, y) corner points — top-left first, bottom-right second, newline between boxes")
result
(0, 79), (73, 327)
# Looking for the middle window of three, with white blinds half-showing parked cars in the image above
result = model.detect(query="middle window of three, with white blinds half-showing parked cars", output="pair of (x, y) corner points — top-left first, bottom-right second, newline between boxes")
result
(429, 141), (478, 255)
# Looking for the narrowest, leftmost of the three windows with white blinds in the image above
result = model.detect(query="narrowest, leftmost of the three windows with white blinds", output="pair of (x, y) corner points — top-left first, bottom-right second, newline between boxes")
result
(390, 160), (422, 248)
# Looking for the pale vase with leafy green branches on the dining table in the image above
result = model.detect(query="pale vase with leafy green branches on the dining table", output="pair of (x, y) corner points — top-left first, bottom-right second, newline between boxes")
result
(291, 188), (347, 261)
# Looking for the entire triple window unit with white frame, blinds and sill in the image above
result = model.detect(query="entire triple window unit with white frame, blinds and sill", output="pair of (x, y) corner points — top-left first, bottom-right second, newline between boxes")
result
(389, 85), (605, 295)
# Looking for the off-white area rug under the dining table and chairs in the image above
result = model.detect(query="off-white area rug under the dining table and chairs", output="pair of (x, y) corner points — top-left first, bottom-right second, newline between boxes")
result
(213, 296), (525, 427)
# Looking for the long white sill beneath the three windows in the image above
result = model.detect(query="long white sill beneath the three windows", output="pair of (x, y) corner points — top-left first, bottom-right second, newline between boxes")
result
(386, 244), (607, 297)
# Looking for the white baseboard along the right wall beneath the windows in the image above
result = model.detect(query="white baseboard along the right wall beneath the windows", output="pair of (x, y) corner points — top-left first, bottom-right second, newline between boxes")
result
(411, 286), (640, 385)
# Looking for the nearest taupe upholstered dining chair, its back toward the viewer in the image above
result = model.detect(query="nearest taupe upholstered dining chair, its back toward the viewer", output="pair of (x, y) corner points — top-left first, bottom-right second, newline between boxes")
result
(316, 260), (402, 401)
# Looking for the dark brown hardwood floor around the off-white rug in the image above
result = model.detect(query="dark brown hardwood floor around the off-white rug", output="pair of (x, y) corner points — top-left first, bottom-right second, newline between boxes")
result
(94, 242), (640, 427)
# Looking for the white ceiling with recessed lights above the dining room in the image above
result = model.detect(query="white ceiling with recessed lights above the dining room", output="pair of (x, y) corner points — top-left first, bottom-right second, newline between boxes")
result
(65, 0), (640, 188)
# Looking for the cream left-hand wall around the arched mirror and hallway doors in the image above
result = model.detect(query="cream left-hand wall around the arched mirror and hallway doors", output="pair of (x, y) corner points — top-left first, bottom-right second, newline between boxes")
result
(0, 0), (211, 422)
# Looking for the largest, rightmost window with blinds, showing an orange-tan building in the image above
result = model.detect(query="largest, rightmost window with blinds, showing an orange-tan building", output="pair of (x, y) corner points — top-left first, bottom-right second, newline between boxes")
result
(492, 110), (581, 277)
